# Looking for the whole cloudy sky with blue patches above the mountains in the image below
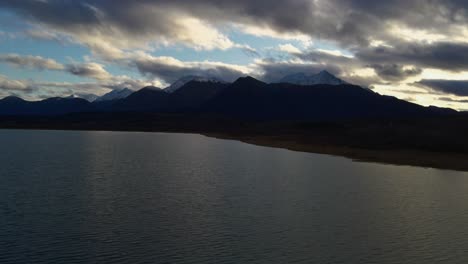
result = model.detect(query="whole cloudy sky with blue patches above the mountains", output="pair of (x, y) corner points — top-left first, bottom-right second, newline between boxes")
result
(0, 0), (468, 110)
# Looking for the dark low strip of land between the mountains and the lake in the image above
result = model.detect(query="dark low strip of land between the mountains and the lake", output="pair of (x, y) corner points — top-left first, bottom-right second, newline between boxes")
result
(0, 115), (468, 171)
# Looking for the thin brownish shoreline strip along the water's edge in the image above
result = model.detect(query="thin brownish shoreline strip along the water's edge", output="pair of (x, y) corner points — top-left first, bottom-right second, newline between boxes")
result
(0, 127), (468, 172)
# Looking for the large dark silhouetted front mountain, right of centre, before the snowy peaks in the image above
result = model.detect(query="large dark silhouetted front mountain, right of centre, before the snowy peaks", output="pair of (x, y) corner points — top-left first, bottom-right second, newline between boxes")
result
(204, 74), (454, 120)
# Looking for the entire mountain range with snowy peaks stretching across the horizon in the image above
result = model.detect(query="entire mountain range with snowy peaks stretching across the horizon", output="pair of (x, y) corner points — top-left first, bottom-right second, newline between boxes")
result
(0, 71), (457, 120)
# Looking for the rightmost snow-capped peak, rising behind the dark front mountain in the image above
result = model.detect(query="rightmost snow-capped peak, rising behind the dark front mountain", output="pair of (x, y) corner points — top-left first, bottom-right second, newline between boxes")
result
(279, 70), (346, 85)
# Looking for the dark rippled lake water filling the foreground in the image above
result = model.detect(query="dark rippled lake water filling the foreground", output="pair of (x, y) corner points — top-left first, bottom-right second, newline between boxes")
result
(0, 130), (468, 264)
